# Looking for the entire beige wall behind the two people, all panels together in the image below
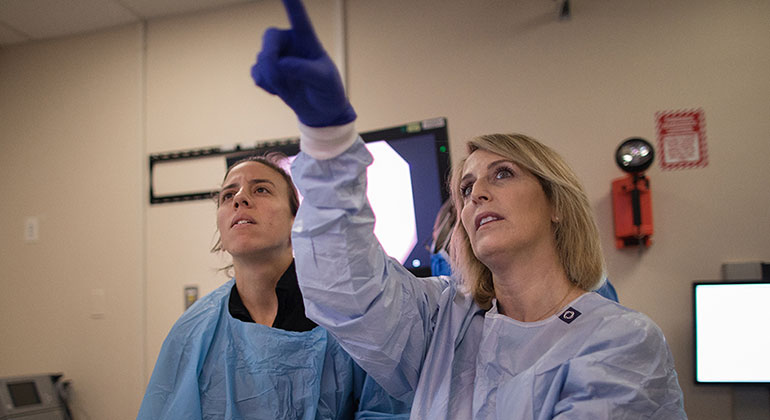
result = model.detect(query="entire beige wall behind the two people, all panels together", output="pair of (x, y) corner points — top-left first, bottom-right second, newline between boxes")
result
(0, 0), (770, 420)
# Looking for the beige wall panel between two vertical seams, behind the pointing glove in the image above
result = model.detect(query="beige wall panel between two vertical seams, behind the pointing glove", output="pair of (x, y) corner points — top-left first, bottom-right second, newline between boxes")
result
(145, 0), (342, 378)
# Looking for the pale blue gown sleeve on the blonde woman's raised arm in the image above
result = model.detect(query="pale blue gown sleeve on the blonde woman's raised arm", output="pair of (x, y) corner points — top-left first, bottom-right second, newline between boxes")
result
(292, 139), (448, 401)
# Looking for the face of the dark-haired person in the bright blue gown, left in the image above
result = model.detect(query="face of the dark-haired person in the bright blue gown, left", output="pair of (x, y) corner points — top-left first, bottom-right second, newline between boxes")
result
(217, 162), (294, 258)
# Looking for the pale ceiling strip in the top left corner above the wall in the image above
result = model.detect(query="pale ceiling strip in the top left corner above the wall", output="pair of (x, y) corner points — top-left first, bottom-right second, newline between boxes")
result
(0, 0), (255, 46)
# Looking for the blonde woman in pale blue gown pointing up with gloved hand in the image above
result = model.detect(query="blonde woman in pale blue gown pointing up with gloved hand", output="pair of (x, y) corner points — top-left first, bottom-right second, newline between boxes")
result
(252, 0), (686, 420)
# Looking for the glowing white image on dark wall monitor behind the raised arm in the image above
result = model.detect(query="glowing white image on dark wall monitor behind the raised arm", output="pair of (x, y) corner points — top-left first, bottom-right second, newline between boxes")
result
(284, 141), (417, 264)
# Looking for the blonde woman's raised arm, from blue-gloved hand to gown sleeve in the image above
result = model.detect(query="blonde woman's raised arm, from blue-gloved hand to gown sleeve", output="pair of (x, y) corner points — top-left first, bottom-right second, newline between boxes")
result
(252, 0), (448, 400)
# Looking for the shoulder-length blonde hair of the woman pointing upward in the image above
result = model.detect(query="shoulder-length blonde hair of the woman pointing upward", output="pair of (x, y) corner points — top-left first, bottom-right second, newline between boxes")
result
(450, 134), (604, 308)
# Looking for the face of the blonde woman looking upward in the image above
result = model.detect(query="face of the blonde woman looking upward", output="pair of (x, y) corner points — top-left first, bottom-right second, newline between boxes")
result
(452, 149), (555, 268)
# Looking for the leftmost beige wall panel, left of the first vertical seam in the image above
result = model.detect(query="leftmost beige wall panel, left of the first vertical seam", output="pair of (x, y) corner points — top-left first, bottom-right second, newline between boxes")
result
(0, 25), (146, 419)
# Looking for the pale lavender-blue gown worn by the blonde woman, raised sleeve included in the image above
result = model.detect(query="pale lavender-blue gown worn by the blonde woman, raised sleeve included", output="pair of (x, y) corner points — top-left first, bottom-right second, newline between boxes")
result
(292, 139), (686, 420)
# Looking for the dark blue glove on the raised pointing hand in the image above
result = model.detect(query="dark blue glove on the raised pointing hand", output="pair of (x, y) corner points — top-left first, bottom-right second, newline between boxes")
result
(251, 0), (356, 127)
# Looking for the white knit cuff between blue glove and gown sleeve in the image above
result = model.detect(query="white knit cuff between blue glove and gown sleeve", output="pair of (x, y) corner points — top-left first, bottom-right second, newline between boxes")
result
(297, 121), (358, 160)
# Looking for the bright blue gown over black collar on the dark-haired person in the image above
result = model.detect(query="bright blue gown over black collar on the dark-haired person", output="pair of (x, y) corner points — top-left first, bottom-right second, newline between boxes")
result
(137, 280), (408, 420)
